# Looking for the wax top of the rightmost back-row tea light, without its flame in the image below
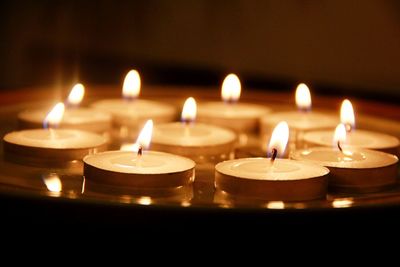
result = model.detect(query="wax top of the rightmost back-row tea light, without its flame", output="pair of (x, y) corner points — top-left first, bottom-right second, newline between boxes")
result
(261, 111), (339, 134)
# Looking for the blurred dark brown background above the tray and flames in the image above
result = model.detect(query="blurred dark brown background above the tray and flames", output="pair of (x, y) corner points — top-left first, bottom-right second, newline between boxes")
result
(0, 0), (400, 102)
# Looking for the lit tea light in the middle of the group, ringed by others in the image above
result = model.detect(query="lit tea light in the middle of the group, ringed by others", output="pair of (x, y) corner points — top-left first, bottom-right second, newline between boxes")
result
(152, 98), (236, 163)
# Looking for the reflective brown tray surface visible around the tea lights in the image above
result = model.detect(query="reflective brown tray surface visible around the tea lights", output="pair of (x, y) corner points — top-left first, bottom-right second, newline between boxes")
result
(0, 86), (400, 228)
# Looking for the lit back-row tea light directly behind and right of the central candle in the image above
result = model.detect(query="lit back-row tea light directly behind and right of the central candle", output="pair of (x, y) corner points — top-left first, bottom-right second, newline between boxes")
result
(197, 74), (270, 144)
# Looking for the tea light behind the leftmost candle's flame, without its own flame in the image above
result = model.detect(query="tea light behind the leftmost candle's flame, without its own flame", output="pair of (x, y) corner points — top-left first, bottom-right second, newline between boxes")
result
(18, 107), (111, 132)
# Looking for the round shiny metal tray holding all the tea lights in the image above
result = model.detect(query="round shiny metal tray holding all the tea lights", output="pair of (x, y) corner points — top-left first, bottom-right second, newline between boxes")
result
(0, 86), (400, 230)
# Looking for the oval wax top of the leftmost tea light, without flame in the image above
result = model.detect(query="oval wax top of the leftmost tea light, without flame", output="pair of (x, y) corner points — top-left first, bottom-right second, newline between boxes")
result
(4, 129), (106, 149)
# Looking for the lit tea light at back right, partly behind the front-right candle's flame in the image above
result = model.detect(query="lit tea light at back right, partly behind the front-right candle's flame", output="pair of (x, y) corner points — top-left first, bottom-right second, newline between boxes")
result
(261, 83), (338, 151)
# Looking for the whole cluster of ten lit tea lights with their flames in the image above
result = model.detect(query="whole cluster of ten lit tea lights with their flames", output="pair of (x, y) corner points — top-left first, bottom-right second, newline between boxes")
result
(3, 70), (399, 201)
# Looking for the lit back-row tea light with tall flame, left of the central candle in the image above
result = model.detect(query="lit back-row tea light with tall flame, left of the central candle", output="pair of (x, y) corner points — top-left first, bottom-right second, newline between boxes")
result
(92, 70), (176, 130)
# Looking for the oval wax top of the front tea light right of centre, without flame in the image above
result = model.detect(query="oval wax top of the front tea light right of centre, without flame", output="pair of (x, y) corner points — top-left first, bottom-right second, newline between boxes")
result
(215, 158), (329, 181)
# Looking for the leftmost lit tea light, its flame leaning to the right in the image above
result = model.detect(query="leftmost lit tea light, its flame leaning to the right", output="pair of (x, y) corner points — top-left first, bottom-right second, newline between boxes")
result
(3, 103), (106, 168)
